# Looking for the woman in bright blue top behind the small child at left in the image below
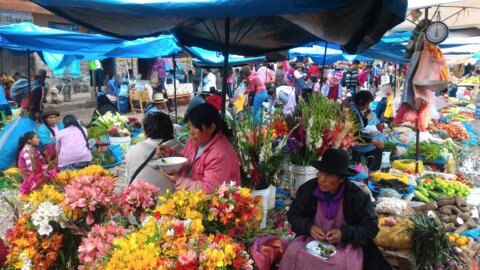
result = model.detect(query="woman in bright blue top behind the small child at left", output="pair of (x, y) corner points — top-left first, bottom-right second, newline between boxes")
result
(37, 107), (63, 159)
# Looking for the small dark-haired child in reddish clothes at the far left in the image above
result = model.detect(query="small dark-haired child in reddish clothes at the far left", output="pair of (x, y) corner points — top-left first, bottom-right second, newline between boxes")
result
(17, 131), (46, 171)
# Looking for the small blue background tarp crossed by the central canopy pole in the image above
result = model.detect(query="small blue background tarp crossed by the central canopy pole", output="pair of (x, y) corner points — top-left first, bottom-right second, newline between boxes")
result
(185, 47), (266, 67)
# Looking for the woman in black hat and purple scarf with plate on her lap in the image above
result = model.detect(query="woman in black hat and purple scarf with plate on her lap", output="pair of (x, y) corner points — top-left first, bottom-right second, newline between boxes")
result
(279, 148), (391, 270)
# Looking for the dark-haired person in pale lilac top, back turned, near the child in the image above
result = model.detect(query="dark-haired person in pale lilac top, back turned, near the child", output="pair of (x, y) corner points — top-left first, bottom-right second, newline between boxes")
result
(55, 115), (92, 171)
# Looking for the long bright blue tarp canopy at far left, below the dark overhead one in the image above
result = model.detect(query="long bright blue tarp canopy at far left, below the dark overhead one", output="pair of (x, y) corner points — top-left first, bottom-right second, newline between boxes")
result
(0, 23), (181, 70)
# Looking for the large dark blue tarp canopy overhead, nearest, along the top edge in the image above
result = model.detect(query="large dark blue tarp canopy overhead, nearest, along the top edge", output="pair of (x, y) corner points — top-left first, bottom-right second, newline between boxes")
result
(33, 0), (407, 55)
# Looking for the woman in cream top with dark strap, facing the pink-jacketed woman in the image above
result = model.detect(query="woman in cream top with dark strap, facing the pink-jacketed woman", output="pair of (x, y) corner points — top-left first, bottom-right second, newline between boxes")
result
(125, 112), (174, 194)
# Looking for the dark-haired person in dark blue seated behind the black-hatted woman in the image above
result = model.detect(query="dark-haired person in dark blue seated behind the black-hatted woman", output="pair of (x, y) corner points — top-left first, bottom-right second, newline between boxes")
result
(350, 91), (385, 171)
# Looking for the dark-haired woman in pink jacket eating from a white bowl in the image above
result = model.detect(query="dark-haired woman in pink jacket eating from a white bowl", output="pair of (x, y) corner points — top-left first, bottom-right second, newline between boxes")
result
(157, 103), (240, 194)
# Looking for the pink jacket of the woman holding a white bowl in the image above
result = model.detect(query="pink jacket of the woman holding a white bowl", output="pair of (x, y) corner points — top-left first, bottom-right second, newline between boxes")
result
(175, 132), (240, 194)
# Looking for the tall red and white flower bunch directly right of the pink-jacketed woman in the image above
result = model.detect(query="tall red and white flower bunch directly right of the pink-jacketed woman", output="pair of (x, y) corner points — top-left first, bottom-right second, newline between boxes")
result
(234, 114), (288, 190)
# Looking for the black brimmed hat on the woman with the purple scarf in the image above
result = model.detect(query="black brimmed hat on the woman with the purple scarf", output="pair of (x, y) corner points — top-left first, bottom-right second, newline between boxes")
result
(310, 148), (358, 176)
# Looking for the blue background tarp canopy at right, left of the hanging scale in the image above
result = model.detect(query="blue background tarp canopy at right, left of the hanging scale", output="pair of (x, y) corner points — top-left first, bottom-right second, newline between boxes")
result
(289, 42), (408, 65)
